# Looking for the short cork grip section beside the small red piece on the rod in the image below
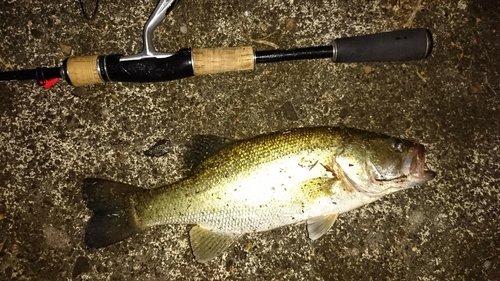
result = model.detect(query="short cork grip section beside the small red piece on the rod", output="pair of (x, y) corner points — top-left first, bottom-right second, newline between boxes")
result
(66, 56), (104, 87)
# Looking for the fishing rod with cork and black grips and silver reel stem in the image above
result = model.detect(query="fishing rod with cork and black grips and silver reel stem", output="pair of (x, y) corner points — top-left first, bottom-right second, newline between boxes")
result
(0, 0), (433, 89)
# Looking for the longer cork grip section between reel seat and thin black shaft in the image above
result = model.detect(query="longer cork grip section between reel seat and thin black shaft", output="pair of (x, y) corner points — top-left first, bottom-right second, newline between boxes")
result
(191, 47), (255, 75)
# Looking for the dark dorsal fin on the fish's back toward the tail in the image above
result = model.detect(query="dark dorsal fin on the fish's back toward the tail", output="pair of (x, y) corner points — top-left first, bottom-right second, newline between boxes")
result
(184, 135), (233, 170)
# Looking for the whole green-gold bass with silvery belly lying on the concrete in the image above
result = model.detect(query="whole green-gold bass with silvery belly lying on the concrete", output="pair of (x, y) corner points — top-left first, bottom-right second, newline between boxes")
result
(82, 127), (436, 263)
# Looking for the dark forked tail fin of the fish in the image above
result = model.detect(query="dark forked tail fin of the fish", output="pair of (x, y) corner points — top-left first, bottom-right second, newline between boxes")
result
(82, 178), (144, 248)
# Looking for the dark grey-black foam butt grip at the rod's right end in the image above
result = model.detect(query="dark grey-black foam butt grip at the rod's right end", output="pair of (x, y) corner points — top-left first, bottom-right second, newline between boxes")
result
(332, 28), (433, 62)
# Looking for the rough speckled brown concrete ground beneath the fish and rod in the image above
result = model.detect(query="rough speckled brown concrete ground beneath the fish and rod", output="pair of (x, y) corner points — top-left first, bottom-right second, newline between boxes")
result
(0, 0), (500, 280)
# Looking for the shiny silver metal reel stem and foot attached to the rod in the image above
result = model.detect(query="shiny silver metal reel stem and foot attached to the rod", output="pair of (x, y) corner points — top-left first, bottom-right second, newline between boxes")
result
(120, 0), (175, 61)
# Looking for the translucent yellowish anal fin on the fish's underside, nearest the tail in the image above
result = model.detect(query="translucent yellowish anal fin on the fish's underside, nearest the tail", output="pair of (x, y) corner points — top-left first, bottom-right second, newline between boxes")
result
(189, 225), (239, 262)
